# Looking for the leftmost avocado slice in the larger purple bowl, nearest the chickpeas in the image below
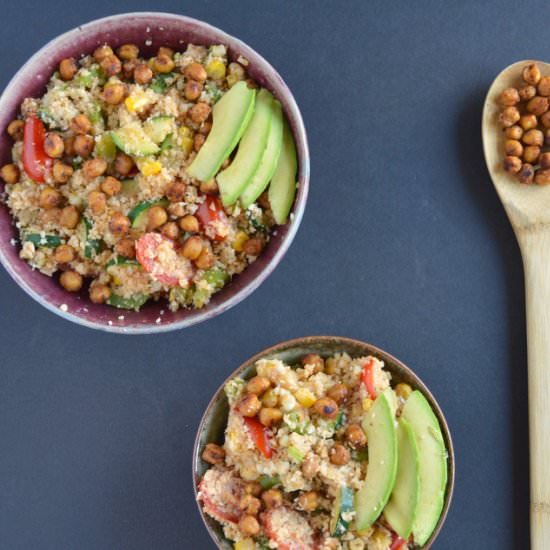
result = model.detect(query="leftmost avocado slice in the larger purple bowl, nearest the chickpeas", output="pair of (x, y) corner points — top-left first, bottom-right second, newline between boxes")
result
(187, 81), (256, 181)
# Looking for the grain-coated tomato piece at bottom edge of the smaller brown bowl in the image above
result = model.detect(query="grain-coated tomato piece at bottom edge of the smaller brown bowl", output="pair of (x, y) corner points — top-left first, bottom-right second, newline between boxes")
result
(261, 506), (317, 550)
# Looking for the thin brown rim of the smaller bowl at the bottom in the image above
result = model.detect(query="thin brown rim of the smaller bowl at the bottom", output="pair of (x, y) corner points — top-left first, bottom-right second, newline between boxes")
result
(191, 335), (456, 550)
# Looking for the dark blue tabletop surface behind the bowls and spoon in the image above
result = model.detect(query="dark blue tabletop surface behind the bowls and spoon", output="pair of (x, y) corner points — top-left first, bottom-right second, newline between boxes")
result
(0, 0), (536, 550)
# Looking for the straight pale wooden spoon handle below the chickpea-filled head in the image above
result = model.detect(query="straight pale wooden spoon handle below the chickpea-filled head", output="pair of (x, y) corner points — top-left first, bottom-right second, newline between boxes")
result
(519, 230), (550, 550)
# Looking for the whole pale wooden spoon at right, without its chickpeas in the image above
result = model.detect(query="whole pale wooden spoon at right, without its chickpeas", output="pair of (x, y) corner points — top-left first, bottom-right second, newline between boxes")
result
(481, 60), (550, 550)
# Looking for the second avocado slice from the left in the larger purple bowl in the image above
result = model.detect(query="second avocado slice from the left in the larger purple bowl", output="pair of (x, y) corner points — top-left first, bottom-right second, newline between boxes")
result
(216, 89), (273, 206)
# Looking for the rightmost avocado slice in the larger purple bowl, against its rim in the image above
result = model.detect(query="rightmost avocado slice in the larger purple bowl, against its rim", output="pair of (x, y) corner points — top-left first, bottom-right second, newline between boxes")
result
(268, 122), (298, 225)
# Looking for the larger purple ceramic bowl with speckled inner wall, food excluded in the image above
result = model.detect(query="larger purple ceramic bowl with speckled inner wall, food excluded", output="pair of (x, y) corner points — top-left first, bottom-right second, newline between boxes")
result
(0, 12), (309, 334)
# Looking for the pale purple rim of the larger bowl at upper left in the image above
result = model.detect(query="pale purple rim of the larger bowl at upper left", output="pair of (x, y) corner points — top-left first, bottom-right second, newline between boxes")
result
(0, 11), (311, 335)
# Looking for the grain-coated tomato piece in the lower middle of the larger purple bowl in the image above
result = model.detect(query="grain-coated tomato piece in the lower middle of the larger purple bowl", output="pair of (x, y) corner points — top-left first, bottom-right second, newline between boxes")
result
(136, 233), (194, 288)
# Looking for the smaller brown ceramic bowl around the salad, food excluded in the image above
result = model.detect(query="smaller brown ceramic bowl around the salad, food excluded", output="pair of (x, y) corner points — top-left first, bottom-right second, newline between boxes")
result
(193, 336), (455, 550)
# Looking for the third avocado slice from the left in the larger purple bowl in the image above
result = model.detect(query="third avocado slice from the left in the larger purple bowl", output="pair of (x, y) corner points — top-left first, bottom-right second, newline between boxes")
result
(240, 100), (283, 208)
